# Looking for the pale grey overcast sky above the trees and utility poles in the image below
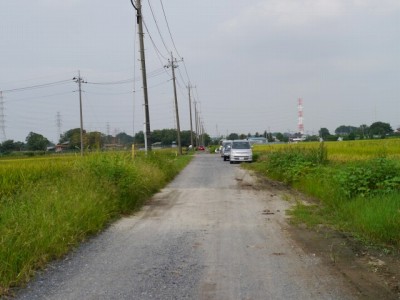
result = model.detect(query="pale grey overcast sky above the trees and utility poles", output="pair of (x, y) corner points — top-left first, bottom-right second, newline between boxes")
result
(0, 0), (400, 142)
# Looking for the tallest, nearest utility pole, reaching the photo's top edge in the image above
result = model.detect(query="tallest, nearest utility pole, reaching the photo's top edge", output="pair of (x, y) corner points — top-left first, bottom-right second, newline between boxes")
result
(131, 0), (151, 152)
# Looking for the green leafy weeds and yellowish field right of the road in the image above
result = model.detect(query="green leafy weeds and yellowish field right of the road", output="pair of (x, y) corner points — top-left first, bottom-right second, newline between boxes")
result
(247, 139), (400, 249)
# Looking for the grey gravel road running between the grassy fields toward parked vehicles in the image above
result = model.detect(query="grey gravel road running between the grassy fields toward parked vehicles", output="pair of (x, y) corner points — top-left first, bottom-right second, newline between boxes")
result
(16, 154), (357, 300)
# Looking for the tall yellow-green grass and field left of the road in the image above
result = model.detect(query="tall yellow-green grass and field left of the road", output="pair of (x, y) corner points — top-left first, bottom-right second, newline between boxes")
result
(0, 151), (191, 297)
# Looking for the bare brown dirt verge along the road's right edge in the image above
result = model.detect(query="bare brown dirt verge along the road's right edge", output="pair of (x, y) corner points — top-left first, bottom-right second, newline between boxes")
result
(253, 173), (400, 299)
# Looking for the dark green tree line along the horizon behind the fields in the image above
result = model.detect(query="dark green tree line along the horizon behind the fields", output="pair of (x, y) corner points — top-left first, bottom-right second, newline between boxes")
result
(0, 122), (400, 153)
